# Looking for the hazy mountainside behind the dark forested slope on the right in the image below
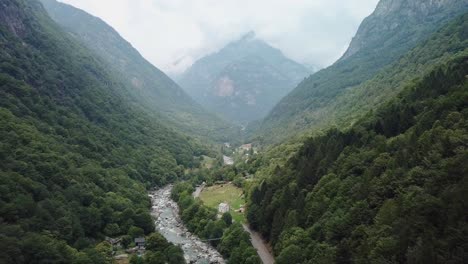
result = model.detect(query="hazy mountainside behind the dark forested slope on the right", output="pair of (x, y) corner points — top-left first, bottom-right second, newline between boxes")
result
(251, 0), (468, 142)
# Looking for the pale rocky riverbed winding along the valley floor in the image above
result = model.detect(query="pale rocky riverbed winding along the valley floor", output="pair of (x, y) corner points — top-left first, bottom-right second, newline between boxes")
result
(149, 185), (225, 264)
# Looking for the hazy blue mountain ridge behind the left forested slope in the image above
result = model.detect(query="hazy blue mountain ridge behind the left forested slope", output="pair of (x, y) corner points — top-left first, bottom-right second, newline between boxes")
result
(41, 0), (239, 141)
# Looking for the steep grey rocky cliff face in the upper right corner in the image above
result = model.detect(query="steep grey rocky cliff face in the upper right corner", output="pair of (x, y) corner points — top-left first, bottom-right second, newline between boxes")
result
(341, 0), (468, 60)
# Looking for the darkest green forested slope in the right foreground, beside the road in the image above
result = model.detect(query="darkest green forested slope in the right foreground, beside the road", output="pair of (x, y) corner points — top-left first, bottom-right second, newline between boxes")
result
(248, 14), (468, 264)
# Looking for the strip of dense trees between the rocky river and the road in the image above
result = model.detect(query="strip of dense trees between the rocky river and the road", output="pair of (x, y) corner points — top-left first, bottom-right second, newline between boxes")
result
(171, 182), (261, 264)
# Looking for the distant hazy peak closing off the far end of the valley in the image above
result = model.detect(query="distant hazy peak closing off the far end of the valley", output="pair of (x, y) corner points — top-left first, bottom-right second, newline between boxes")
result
(178, 32), (310, 124)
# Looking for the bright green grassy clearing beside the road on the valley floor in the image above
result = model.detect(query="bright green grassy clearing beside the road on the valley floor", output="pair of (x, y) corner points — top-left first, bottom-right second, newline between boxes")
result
(200, 183), (245, 223)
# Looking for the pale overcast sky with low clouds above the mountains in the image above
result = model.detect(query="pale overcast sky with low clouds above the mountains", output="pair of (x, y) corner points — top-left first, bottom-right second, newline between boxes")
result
(60, 0), (378, 75)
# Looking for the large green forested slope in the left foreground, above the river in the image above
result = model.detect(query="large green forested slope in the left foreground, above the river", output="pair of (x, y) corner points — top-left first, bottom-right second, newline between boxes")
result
(0, 0), (202, 263)
